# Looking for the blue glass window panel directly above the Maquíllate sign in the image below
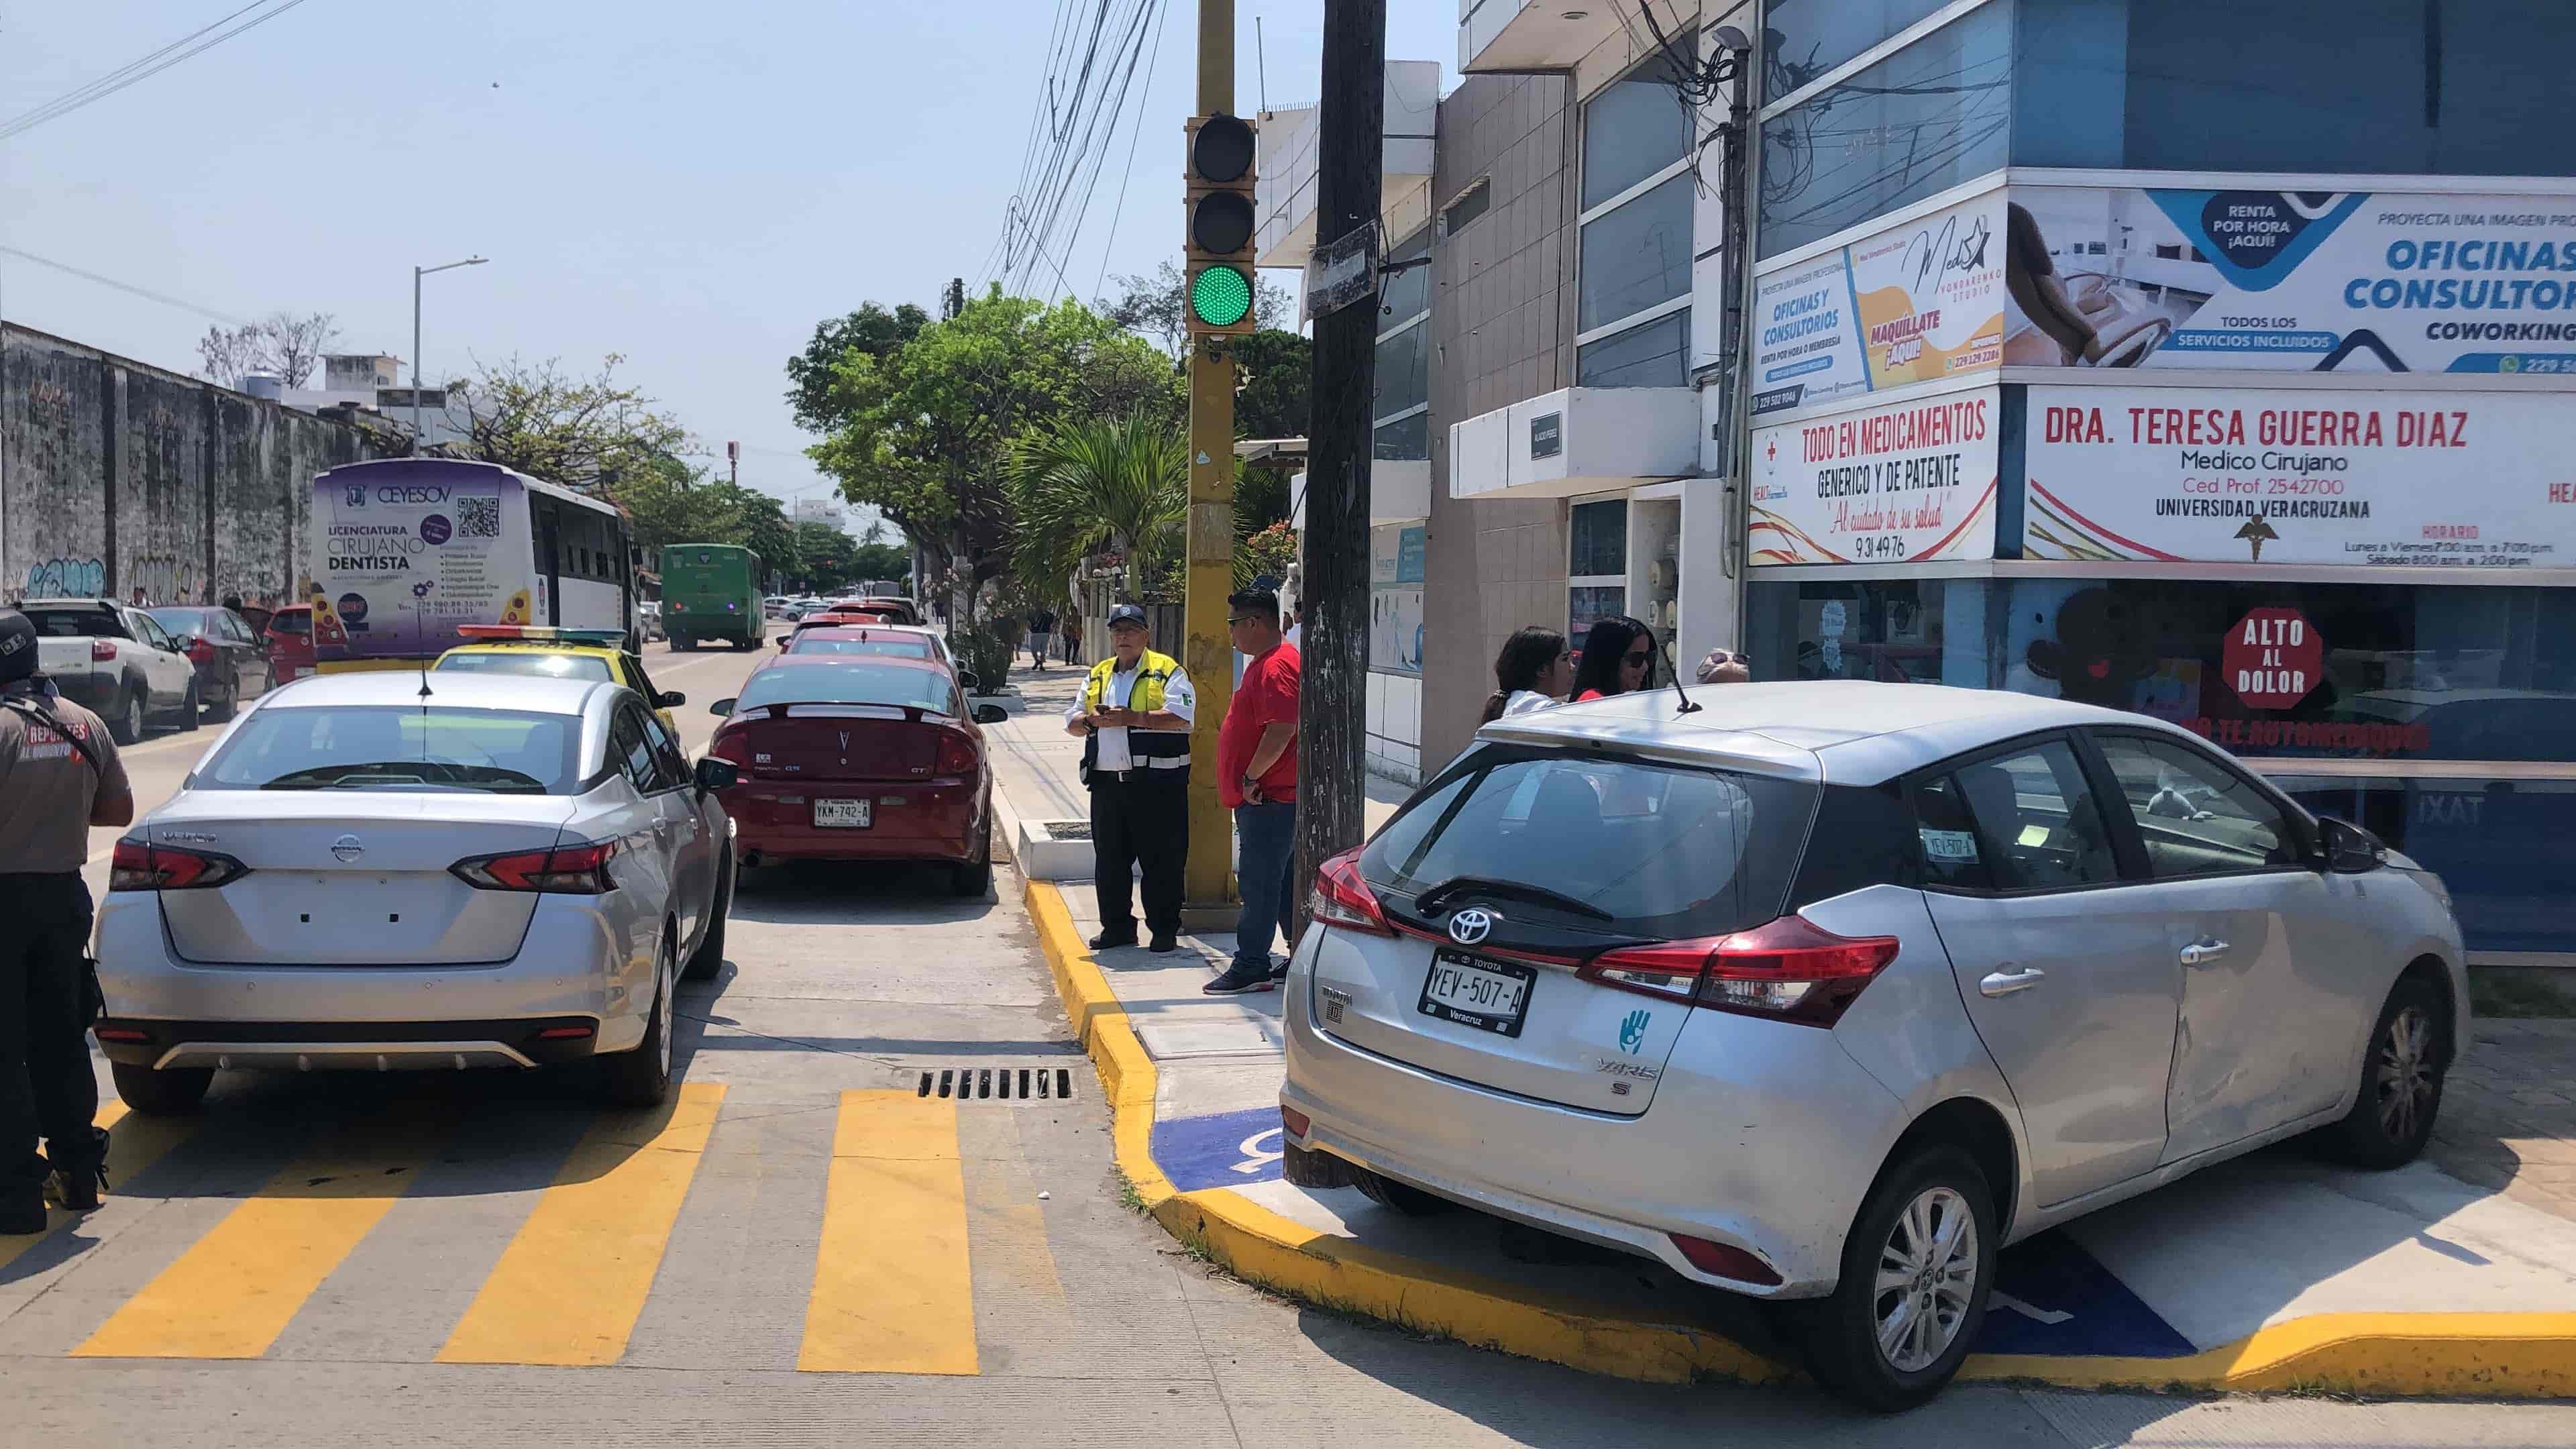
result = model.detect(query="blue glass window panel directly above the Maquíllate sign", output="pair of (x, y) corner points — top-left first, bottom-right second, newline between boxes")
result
(1757, 0), (2015, 255)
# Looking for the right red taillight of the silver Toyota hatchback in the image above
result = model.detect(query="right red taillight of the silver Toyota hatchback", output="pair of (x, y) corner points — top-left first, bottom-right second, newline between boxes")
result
(1576, 915), (1896, 1026)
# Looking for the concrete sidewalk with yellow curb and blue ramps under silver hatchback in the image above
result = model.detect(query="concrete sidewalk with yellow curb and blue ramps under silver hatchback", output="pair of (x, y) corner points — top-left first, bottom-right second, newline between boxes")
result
(991, 670), (2576, 1395)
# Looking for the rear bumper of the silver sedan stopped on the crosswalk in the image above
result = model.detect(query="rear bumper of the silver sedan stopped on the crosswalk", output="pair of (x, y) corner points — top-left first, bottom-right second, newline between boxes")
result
(93, 892), (657, 1070)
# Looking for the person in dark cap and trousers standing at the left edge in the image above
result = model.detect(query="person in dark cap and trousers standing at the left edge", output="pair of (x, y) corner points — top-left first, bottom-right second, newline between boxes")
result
(0, 608), (134, 1235)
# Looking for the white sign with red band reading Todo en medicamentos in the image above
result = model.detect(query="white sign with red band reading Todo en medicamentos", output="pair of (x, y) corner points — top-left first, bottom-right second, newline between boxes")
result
(1749, 389), (2002, 565)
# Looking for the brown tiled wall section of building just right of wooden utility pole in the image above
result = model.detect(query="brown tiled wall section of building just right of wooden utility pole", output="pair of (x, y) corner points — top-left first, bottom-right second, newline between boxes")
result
(1422, 74), (1574, 776)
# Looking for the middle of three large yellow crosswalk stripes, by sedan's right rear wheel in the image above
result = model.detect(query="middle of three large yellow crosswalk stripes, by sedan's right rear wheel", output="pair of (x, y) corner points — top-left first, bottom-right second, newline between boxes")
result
(438, 1083), (724, 1364)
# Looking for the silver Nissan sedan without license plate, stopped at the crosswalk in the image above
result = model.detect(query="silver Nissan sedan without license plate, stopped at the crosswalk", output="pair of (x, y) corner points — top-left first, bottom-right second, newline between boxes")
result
(95, 670), (734, 1112)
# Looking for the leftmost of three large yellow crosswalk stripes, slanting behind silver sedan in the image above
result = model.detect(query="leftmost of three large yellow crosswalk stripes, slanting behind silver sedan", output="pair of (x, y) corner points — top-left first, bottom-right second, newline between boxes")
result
(72, 1109), (435, 1358)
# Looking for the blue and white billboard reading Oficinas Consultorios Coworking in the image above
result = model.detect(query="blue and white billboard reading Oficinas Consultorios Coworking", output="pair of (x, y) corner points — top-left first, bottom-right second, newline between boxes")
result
(1998, 186), (2576, 374)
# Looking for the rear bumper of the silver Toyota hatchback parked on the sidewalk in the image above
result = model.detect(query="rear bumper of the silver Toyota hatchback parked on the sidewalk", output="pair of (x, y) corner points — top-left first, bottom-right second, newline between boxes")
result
(1280, 930), (1904, 1297)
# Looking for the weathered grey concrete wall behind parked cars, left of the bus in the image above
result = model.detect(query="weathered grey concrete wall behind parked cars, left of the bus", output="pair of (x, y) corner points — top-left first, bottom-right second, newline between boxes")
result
(0, 327), (376, 606)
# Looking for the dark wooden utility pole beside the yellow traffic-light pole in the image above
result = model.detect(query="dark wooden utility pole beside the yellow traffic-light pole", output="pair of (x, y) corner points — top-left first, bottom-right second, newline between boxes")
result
(1296, 0), (1386, 920)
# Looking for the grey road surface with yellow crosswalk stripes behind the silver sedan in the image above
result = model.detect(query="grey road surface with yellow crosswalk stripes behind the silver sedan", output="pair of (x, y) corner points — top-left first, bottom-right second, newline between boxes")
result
(0, 637), (2576, 1449)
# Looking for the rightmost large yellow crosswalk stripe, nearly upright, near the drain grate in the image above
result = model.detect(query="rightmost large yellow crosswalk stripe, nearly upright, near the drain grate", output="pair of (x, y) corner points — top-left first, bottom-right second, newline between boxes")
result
(796, 1091), (976, 1375)
